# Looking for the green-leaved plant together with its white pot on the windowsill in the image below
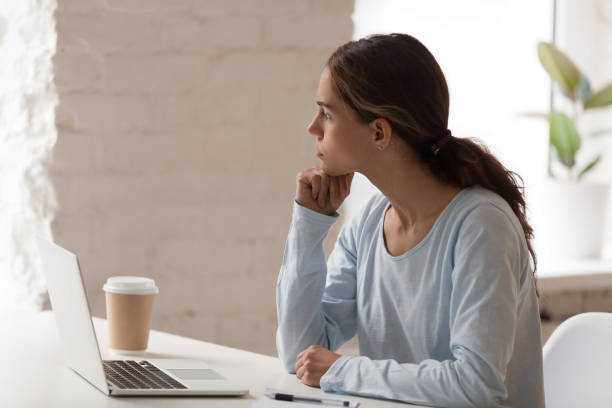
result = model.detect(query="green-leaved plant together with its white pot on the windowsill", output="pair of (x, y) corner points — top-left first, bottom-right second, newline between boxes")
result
(532, 42), (612, 259)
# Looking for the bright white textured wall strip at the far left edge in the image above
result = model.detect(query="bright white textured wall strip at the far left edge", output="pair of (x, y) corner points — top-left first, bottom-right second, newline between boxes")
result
(0, 0), (57, 309)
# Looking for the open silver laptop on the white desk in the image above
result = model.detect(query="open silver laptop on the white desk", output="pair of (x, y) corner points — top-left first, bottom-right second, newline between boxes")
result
(37, 237), (249, 396)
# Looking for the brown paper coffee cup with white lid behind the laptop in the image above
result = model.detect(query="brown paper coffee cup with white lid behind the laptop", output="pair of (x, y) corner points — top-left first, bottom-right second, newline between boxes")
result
(103, 276), (159, 354)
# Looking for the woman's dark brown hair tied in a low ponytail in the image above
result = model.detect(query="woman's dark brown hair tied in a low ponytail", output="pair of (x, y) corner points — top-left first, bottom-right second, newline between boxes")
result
(327, 33), (538, 293)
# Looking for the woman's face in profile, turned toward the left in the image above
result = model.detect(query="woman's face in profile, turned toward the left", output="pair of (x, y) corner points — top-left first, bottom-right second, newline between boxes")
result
(308, 67), (376, 176)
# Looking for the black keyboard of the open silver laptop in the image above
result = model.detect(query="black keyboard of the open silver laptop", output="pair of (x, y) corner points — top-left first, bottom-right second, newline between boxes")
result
(104, 360), (187, 390)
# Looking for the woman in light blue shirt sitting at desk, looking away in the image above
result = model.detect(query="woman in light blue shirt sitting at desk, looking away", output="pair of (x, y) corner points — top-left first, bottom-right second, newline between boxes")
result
(277, 34), (544, 407)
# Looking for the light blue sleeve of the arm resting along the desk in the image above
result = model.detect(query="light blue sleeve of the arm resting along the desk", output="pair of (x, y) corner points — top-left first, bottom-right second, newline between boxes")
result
(321, 205), (522, 407)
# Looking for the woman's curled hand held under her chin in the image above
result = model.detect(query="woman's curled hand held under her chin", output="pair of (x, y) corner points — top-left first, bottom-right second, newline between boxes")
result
(295, 167), (355, 215)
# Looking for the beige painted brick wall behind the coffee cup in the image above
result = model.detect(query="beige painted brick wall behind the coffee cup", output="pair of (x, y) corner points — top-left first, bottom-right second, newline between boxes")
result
(52, 0), (353, 354)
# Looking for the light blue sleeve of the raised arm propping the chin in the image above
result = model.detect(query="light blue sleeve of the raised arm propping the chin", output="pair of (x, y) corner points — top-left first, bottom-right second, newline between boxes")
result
(276, 202), (357, 373)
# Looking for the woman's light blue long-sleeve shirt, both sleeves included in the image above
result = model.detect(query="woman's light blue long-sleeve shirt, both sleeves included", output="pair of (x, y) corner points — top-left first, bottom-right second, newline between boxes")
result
(276, 186), (544, 407)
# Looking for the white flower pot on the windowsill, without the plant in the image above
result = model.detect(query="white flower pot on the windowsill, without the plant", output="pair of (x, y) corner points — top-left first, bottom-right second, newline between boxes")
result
(527, 180), (609, 262)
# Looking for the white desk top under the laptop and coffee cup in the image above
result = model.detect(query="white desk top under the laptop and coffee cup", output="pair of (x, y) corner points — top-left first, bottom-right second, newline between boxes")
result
(0, 312), (414, 408)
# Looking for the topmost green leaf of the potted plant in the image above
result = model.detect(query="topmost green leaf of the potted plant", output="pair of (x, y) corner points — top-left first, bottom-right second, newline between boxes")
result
(538, 41), (581, 99)
